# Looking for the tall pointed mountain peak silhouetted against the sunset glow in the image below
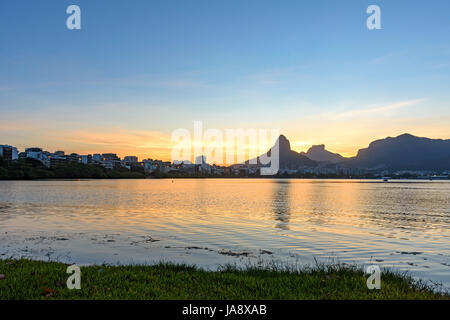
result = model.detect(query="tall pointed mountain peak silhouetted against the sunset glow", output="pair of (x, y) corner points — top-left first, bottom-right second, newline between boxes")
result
(246, 135), (317, 169)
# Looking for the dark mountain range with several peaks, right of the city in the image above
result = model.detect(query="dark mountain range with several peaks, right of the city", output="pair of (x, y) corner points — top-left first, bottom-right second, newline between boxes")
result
(250, 134), (450, 170)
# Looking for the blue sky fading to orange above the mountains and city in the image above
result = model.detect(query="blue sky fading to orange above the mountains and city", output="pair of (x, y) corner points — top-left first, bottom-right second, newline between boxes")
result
(0, 0), (450, 160)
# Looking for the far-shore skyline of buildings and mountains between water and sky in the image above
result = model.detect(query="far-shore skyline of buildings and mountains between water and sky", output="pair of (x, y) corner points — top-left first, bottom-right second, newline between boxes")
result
(0, 134), (450, 181)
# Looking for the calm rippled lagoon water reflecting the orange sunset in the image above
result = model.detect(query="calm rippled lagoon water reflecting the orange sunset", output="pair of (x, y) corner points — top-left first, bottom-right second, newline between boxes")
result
(0, 179), (450, 288)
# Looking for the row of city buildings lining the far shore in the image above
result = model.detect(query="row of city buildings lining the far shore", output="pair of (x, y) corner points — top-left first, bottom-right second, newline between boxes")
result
(0, 145), (450, 178)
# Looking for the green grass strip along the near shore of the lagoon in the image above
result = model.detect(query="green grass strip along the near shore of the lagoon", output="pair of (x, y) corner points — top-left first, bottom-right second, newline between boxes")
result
(0, 259), (450, 300)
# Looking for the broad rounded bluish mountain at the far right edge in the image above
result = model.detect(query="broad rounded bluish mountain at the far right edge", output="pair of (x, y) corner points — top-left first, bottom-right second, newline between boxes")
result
(344, 134), (450, 170)
